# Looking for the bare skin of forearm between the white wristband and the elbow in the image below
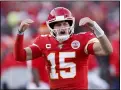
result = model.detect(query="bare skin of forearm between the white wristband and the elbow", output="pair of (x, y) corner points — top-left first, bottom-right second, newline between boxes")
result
(98, 34), (113, 54)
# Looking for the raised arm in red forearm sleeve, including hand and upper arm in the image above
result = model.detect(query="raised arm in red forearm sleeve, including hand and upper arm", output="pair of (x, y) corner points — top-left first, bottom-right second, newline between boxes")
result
(14, 19), (40, 61)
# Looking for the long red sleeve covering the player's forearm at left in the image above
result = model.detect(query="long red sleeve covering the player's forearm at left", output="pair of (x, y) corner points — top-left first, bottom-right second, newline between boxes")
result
(14, 35), (26, 61)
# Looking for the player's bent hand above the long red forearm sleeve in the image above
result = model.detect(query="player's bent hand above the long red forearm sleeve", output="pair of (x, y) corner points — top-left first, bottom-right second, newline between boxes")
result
(19, 19), (34, 32)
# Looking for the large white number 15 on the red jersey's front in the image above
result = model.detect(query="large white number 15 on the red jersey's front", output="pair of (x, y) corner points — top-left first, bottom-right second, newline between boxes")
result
(47, 52), (76, 79)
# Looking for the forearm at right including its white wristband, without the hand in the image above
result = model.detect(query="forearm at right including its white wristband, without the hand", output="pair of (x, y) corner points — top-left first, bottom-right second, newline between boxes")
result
(92, 21), (113, 54)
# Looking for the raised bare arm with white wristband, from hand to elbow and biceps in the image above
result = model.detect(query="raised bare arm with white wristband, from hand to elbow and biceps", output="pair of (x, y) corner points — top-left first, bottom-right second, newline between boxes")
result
(79, 17), (113, 56)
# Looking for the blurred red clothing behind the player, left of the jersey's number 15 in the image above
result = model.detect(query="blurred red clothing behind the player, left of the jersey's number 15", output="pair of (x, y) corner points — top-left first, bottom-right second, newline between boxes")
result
(32, 57), (49, 84)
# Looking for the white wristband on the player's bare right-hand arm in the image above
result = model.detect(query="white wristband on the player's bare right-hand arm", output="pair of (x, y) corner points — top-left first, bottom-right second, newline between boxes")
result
(91, 21), (104, 38)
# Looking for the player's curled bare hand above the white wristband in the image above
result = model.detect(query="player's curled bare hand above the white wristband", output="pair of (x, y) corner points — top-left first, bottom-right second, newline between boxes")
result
(79, 17), (94, 27)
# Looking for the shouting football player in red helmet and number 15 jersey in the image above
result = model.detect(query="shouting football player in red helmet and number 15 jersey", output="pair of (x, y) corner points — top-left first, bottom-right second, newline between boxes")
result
(15, 7), (113, 89)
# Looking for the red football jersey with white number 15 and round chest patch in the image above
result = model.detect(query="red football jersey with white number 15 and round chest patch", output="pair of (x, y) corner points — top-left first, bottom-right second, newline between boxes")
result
(30, 32), (95, 89)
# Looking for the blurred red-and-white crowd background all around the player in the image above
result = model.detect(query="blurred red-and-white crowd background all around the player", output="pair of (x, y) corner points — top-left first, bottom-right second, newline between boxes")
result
(1, 1), (120, 89)
